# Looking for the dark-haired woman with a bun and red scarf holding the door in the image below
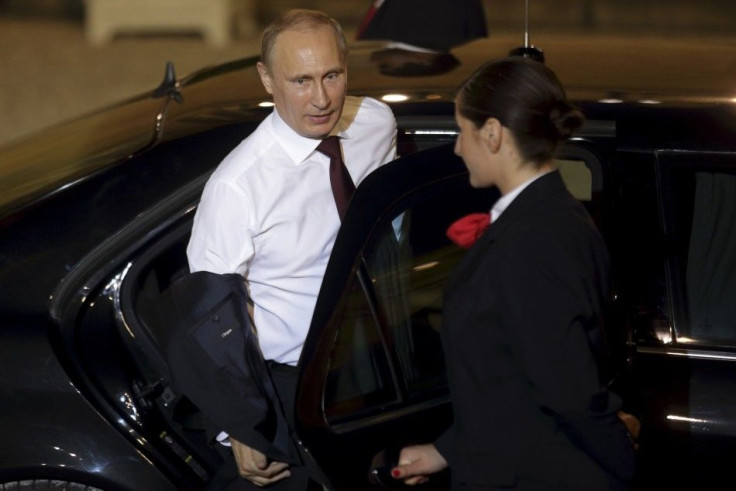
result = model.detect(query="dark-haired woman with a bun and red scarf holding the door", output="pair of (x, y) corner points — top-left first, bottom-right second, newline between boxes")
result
(392, 57), (634, 491)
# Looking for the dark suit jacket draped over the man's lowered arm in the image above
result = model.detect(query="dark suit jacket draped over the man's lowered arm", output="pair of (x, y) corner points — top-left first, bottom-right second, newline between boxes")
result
(155, 271), (298, 463)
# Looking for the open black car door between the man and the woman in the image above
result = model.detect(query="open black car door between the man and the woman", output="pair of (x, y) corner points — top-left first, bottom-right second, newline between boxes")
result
(296, 144), (497, 490)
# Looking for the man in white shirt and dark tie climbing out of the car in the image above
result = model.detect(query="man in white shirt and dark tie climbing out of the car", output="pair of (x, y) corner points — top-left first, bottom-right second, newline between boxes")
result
(187, 9), (396, 489)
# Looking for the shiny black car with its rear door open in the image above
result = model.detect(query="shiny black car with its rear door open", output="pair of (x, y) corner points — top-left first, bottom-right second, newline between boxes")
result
(0, 35), (736, 490)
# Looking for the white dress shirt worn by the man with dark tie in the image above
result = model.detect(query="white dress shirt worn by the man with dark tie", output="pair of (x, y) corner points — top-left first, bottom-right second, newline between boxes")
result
(187, 97), (396, 365)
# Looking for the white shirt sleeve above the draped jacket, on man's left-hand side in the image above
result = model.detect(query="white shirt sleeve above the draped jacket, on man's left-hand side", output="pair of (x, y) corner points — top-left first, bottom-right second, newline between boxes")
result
(187, 180), (254, 276)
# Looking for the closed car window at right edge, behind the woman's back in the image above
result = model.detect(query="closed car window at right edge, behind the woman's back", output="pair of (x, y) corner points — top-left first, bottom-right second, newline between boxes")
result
(663, 157), (736, 346)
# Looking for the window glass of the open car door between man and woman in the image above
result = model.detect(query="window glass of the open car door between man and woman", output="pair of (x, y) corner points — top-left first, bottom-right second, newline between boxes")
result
(324, 148), (600, 423)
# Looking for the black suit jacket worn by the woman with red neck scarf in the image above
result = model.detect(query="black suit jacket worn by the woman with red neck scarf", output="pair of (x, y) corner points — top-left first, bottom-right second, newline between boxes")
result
(436, 172), (634, 489)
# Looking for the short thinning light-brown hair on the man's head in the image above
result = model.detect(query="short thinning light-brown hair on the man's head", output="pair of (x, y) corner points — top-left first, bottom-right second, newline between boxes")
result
(261, 9), (348, 68)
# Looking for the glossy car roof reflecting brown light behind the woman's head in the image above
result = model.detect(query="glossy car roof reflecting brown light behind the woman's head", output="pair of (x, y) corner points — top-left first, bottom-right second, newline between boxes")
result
(342, 33), (736, 104)
